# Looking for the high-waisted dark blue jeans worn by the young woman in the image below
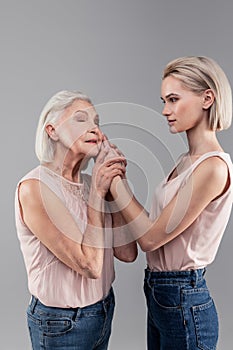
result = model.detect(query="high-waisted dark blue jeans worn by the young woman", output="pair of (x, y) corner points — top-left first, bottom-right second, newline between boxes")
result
(144, 269), (218, 350)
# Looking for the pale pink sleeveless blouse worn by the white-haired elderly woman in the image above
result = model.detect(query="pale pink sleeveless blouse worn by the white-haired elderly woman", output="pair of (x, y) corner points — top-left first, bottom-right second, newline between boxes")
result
(15, 166), (114, 308)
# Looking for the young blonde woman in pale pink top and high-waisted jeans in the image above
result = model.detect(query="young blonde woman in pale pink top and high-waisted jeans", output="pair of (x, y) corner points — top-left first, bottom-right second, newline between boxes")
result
(111, 57), (233, 350)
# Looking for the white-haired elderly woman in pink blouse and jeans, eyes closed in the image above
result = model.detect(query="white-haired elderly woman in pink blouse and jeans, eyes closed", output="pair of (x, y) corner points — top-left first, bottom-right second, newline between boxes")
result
(15, 91), (137, 350)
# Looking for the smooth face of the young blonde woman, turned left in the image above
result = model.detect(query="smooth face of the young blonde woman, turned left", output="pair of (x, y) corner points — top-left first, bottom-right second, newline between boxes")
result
(161, 76), (205, 133)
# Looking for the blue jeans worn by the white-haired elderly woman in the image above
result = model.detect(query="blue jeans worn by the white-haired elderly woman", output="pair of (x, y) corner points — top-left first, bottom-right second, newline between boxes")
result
(27, 289), (115, 350)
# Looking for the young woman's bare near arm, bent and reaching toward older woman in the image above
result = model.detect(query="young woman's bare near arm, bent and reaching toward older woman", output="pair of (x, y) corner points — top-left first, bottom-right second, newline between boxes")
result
(111, 157), (228, 251)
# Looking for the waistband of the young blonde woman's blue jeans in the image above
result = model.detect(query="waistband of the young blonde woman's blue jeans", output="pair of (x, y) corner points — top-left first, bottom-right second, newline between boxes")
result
(145, 267), (206, 284)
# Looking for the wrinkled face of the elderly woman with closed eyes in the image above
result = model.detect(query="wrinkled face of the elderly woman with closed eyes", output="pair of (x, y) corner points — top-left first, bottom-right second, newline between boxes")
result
(55, 100), (103, 156)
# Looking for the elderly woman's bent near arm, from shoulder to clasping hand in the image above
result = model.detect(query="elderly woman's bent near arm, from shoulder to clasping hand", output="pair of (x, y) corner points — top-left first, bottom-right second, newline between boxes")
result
(19, 150), (126, 278)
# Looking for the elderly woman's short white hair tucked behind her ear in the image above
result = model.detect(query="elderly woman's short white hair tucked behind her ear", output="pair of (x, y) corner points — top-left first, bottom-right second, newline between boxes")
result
(35, 90), (92, 163)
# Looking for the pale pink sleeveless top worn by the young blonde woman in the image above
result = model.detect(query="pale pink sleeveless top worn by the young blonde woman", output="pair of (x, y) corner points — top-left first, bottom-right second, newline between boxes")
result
(146, 152), (233, 271)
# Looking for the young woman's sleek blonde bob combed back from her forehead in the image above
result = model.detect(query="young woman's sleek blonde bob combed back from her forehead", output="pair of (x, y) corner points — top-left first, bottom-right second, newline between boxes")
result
(162, 56), (232, 130)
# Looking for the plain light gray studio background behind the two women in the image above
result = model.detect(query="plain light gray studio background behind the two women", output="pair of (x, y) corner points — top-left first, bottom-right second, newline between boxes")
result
(0, 0), (233, 350)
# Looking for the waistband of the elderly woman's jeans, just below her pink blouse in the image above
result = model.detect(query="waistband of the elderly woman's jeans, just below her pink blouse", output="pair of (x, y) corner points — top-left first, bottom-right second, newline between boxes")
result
(29, 287), (114, 316)
